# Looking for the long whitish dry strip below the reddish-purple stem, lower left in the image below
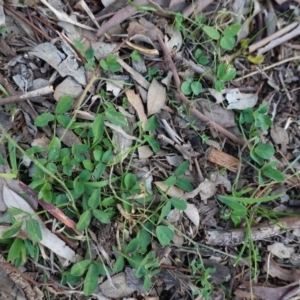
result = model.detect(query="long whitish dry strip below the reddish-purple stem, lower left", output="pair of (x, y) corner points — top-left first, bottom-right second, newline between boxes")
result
(3, 186), (77, 265)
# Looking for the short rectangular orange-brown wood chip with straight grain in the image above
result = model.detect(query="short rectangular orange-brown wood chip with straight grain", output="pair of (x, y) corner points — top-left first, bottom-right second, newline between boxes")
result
(206, 147), (240, 173)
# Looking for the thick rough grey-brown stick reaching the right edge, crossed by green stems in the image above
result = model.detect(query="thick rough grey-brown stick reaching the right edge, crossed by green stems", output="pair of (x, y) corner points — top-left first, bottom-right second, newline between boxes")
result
(205, 217), (300, 246)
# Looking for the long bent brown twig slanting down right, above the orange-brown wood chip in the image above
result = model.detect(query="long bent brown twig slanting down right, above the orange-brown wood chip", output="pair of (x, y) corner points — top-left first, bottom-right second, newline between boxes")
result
(157, 35), (245, 146)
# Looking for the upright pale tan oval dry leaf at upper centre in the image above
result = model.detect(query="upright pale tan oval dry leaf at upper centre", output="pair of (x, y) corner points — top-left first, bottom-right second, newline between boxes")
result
(147, 78), (167, 116)
